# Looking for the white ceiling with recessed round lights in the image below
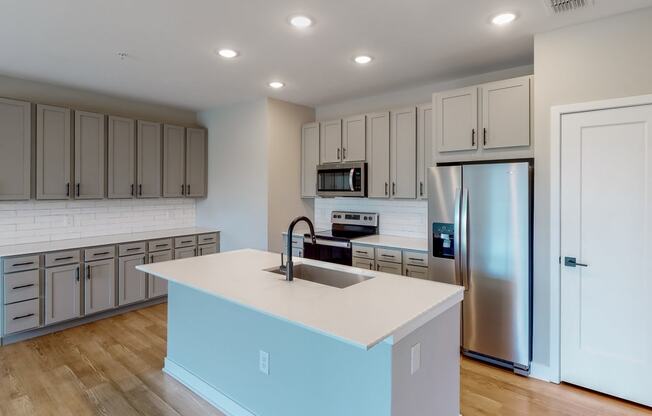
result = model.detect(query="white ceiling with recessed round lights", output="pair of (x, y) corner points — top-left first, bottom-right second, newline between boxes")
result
(0, 0), (652, 110)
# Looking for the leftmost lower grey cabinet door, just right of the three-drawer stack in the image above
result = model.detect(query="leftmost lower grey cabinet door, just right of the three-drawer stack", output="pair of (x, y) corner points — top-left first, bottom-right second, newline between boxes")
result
(45, 264), (81, 325)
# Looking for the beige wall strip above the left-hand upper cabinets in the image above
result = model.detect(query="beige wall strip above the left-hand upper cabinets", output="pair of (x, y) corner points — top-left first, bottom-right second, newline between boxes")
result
(0, 75), (197, 126)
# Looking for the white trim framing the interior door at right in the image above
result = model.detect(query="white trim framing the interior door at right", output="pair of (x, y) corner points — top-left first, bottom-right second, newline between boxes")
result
(550, 95), (652, 383)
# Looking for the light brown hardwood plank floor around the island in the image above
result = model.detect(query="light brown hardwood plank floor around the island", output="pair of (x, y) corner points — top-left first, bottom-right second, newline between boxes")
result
(0, 304), (652, 416)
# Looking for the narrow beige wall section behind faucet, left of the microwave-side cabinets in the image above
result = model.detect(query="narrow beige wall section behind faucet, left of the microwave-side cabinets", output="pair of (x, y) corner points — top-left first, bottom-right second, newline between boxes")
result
(267, 99), (315, 253)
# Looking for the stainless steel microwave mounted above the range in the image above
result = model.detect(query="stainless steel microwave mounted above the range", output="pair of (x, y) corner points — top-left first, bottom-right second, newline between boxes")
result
(317, 162), (367, 198)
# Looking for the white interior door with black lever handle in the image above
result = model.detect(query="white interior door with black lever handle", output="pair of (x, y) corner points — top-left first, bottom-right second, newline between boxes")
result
(561, 105), (652, 406)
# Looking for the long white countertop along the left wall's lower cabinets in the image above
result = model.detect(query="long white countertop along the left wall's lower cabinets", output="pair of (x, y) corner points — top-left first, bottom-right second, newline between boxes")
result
(0, 227), (219, 257)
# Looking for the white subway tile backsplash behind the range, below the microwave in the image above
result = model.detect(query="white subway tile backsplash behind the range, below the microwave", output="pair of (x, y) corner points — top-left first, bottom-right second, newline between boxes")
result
(315, 198), (428, 238)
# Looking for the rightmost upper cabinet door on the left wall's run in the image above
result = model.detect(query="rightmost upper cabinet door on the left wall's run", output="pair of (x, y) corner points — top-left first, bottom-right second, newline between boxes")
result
(186, 129), (208, 198)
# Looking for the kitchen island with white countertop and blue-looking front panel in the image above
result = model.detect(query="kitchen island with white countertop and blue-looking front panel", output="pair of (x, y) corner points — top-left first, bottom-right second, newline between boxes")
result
(138, 250), (463, 416)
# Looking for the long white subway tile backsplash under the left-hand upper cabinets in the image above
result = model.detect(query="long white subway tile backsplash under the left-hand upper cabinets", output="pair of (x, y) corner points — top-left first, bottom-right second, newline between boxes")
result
(0, 198), (195, 245)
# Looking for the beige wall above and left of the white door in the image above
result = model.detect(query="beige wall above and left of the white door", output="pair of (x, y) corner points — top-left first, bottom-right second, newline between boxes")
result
(534, 8), (652, 366)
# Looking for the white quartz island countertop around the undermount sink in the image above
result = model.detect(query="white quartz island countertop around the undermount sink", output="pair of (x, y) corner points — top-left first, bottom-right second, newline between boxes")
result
(137, 249), (464, 349)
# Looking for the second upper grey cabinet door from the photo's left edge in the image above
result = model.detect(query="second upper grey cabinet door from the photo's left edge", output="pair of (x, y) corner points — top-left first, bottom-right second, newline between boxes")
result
(36, 105), (72, 199)
